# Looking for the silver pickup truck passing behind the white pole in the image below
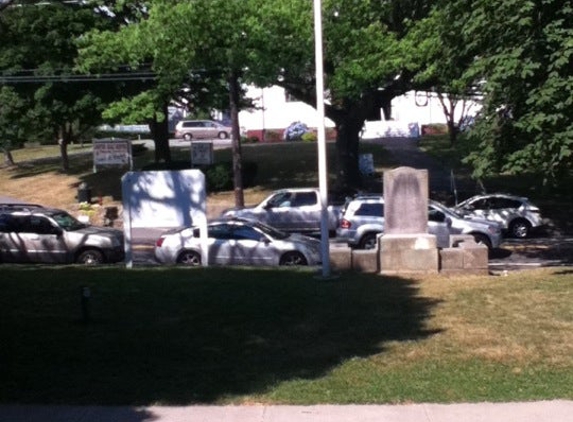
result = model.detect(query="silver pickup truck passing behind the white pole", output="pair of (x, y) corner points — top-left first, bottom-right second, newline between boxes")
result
(221, 188), (344, 235)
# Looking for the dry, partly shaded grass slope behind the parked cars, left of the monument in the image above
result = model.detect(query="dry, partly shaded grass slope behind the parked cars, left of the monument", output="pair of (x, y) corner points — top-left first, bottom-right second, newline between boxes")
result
(0, 141), (389, 216)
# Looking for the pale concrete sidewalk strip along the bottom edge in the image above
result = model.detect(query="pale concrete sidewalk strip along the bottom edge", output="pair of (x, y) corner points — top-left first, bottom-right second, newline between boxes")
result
(0, 400), (573, 422)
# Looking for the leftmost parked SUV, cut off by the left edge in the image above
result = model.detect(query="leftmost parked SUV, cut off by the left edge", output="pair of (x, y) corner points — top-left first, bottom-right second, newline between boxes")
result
(0, 204), (124, 264)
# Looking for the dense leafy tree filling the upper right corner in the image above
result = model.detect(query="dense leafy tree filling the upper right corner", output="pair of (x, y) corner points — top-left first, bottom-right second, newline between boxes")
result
(461, 0), (573, 182)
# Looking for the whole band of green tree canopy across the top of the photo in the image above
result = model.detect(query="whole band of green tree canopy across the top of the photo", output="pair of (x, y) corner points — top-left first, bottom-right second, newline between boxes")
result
(0, 0), (573, 187)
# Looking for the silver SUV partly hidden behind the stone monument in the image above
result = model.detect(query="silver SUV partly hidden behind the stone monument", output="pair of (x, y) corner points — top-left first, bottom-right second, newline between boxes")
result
(336, 195), (502, 249)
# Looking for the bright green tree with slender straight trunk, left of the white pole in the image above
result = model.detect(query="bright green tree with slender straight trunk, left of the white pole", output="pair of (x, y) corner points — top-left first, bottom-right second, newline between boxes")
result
(78, 0), (260, 206)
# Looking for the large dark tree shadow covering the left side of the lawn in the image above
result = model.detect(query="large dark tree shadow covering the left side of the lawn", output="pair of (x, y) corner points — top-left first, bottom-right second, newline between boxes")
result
(0, 267), (438, 405)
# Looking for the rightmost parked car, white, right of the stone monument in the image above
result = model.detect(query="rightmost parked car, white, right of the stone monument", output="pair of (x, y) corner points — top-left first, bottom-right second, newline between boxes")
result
(456, 193), (544, 239)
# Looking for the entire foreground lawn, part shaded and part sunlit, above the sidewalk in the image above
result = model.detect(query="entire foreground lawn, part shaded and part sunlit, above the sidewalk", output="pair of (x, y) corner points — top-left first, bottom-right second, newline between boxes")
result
(0, 266), (573, 405)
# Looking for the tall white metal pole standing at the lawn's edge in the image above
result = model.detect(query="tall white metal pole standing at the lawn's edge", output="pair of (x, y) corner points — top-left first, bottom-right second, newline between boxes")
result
(314, 0), (330, 277)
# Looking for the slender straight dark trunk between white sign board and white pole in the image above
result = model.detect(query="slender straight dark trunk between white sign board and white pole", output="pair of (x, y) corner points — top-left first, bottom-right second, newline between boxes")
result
(229, 71), (245, 208)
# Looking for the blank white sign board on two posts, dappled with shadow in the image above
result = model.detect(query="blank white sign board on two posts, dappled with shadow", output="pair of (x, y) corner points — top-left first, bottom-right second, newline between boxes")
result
(121, 170), (208, 267)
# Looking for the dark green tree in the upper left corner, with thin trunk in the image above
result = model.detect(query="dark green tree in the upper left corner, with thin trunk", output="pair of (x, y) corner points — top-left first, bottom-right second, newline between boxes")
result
(0, 3), (120, 171)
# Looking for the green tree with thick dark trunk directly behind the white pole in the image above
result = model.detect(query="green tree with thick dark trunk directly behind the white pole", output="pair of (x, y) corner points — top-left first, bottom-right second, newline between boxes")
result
(244, 0), (432, 188)
